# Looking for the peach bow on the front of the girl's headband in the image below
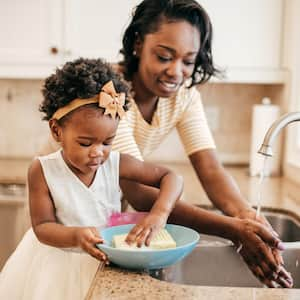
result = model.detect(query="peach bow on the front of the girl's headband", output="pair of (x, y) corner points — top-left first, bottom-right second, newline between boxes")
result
(99, 81), (126, 119)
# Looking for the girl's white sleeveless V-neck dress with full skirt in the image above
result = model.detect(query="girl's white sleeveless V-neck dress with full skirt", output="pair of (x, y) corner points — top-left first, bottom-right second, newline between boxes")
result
(0, 150), (121, 300)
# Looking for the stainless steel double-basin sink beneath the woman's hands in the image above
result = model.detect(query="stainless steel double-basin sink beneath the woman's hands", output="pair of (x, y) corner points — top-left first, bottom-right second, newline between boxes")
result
(150, 213), (300, 288)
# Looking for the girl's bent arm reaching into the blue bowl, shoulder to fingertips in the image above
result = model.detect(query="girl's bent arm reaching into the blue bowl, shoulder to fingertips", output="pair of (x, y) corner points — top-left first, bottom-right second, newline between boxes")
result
(120, 154), (183, 246)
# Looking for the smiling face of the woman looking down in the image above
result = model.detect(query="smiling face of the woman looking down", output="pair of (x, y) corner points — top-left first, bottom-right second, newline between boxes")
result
(135, 21), (200, 97)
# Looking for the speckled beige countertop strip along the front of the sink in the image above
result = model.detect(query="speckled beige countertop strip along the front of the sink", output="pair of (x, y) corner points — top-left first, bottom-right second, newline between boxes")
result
(86, 265), (300, 300)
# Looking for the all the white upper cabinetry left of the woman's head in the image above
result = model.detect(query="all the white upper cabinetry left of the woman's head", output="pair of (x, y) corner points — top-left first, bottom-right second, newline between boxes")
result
(0, 0), (139, 78)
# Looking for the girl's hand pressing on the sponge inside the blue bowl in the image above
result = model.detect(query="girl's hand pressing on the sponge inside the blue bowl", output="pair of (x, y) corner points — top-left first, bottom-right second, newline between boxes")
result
(125, 212), (168, 247)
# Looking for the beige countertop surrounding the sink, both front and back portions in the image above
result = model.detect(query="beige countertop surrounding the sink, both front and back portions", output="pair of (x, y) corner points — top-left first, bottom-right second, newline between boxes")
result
(86, 164), (300, 300)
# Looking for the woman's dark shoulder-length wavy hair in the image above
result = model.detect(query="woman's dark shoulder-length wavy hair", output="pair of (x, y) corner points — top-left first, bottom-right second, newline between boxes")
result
(120, 0), (219, 86)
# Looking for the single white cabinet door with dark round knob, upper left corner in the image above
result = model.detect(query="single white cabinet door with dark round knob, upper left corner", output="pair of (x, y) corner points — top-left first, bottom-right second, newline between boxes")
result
(0, 0), (62, 78)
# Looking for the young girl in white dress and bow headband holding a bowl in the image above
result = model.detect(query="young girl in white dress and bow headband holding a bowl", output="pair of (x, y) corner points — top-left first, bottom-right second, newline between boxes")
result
(0, 59), (182, 300)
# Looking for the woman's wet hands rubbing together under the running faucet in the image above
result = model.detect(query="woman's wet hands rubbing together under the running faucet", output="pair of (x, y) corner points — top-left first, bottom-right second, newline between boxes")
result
(232, 214), (293, 287)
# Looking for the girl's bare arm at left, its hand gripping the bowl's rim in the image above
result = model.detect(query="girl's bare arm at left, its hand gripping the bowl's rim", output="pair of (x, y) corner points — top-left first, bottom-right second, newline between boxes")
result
(28, 159), (106, 260)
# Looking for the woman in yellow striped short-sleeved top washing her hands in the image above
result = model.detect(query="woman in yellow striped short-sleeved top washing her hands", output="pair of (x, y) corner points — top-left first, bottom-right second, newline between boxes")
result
(41, 0), (292, 287)
